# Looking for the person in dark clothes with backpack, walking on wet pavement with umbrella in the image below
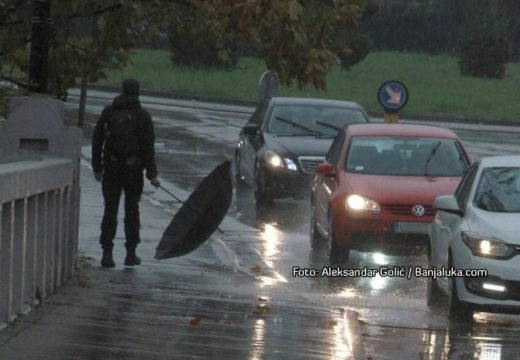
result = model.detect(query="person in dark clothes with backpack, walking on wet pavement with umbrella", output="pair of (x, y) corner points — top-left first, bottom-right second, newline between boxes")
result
(92, 79), (160, 267)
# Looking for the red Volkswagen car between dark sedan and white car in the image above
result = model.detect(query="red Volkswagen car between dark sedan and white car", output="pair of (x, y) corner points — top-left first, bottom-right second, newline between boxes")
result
(310, 123), (471, 258)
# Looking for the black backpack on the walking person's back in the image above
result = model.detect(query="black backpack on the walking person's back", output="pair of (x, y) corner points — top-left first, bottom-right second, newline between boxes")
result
(105, 109), (139, 160)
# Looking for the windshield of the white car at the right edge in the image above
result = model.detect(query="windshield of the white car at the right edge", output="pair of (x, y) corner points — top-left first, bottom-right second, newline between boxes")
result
(474, 167), (520, 213)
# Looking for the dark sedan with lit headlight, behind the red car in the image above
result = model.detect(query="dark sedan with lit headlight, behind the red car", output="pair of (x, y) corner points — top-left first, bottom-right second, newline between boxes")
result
(235, 97), (368, 207)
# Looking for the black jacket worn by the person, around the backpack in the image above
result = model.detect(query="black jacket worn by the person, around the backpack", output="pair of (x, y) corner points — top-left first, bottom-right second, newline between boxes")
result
(92, 93), (157, 179)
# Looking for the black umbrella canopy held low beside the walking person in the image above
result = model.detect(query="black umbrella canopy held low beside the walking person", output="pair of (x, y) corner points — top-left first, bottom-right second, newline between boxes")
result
(155, 160), (233, 259)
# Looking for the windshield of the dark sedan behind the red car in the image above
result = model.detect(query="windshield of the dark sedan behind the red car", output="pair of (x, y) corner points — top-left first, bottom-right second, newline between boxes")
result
(267, 105), (367, 137)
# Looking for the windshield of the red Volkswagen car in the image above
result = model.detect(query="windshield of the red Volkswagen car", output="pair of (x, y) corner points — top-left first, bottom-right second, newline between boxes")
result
(345, 136), (468, 177)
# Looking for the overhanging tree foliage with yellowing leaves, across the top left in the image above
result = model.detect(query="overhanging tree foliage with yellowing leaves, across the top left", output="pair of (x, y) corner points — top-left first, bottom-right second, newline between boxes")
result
(0, 0), (365, 117)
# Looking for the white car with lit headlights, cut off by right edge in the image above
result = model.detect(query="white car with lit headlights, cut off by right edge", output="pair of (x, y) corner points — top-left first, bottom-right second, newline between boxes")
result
(427, 156), (520, 318)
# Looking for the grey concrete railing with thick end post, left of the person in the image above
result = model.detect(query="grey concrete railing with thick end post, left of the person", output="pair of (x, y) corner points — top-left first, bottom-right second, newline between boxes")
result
(0, 96), (81, 329)
